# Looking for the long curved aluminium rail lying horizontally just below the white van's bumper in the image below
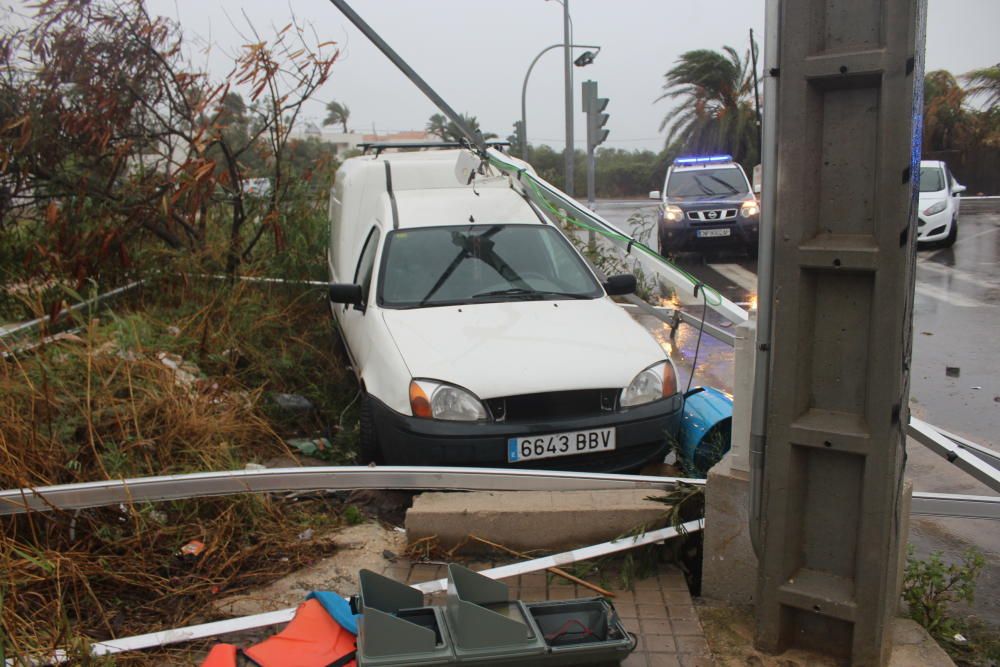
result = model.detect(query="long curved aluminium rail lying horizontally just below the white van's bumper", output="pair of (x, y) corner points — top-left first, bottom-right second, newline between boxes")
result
(0, 466), (1000, 519)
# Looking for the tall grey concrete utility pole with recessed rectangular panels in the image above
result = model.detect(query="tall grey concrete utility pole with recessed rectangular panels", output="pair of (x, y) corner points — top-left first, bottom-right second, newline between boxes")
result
(756, 0), (925, 665)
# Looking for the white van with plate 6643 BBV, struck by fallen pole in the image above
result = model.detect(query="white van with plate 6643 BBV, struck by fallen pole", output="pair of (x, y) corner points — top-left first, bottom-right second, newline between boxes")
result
(328, 150), (683, 472)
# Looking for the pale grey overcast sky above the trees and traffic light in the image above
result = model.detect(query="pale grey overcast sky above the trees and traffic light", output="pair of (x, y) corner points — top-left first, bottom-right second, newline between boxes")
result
(119, 0), (1000, 150)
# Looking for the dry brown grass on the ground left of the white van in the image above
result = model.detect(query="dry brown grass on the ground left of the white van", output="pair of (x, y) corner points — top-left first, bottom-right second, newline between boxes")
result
(0, 281), (354, 658)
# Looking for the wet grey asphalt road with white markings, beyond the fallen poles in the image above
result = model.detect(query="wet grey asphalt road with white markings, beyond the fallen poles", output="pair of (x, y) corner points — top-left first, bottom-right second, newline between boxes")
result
(597, 201), (1000, 627)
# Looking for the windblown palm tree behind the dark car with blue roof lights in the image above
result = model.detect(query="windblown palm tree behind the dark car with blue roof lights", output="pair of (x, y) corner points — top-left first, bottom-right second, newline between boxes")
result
(656, 44), (760, 167)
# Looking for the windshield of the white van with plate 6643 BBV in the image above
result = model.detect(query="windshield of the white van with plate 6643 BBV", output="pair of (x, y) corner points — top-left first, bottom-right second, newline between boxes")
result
(378, 225), (604, 308)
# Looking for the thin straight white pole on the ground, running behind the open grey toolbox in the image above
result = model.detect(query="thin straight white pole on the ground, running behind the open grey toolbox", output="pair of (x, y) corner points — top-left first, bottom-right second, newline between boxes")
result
(7, 519), (705, 666)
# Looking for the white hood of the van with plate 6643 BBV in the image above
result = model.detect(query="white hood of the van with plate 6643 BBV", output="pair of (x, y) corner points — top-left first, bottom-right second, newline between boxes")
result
(381, 298), (666, 399)
